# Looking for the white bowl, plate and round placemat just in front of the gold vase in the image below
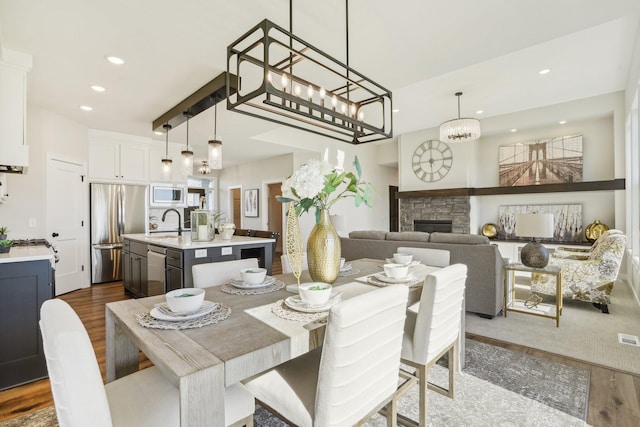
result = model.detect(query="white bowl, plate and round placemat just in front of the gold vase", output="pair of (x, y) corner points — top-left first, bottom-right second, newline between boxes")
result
(271, 282), (342, 321)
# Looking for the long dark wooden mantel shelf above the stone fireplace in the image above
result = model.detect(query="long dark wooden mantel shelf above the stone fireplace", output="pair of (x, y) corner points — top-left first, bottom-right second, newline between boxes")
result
(396, 178), (625, 199)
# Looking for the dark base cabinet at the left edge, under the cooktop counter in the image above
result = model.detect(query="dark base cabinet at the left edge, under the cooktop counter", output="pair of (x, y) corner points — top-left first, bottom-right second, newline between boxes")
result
(0, 260), (55, 390)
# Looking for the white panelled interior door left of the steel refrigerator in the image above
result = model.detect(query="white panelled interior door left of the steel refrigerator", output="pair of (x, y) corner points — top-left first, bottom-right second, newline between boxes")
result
(46, 157), (89, 295)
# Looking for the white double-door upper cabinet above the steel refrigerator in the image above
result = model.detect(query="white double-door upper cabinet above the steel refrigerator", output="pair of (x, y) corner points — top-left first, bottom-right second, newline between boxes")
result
(89, 141), (149, 183)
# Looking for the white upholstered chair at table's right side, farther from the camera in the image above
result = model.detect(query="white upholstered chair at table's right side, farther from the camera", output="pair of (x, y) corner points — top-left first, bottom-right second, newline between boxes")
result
(398, 264), (467, 427)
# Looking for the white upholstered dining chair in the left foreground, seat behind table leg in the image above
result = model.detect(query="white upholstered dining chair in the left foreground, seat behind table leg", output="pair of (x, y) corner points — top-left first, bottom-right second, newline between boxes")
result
(40, 299), (255, 427)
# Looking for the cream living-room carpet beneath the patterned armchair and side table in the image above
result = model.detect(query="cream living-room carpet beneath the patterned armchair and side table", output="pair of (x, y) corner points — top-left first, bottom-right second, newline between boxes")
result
(466, 281), (640, 375)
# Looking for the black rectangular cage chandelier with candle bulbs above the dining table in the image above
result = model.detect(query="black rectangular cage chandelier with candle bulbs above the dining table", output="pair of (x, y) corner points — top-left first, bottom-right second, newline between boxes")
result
(227, 19), (393, 144)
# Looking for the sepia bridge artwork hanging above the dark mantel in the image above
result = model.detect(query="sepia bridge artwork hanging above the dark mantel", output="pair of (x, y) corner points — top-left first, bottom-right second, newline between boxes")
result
(498, 135), (582, 187)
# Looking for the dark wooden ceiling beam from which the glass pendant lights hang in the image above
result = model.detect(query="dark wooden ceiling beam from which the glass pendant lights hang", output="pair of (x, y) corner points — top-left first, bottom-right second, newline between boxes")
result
(152, 71), (238, 132)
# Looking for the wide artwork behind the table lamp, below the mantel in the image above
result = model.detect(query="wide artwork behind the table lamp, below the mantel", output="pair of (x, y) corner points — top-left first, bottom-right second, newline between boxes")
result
(498, 204), (583, 242)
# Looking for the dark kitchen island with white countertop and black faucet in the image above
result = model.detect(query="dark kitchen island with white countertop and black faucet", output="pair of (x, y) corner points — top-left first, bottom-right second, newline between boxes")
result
(122, 233), (276, 297)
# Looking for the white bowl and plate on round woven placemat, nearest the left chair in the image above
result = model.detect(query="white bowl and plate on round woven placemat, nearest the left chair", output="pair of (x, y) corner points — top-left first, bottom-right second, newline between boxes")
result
(136, 288), (231, 330)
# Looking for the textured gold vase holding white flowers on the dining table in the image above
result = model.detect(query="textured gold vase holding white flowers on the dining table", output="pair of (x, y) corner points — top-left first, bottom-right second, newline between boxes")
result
(307, 209), (340, 283)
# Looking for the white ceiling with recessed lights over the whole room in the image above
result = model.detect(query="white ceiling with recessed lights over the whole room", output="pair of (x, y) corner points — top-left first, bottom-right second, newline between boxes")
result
(0, 0), (640, 166)
